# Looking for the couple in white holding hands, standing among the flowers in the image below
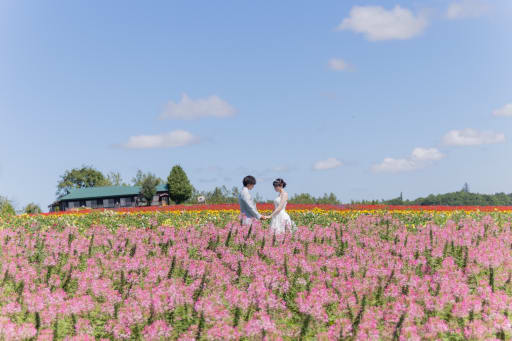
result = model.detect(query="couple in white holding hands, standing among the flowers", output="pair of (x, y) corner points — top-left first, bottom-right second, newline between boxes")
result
(238, 175), (296, 233)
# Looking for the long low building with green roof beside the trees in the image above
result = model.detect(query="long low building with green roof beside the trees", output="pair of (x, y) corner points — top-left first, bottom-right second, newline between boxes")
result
(48, 184), (169, 212)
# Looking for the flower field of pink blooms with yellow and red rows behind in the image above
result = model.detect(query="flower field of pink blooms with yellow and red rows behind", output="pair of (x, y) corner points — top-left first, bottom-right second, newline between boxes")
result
(0, 206), (512, 340)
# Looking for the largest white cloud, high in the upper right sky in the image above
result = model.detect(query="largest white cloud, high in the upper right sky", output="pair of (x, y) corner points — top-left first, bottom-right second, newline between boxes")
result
(338, 6), (428, 41)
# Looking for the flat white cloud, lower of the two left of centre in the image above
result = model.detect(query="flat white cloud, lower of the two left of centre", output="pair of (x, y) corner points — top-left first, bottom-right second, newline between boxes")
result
(123, 130), (199, 149)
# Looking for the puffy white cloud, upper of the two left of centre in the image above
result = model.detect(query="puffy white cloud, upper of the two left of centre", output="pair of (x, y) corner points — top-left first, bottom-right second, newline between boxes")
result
(160, 94), (236, 120)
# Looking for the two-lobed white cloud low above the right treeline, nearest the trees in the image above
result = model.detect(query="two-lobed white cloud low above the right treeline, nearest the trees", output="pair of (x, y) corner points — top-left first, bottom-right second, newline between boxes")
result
(372, 147), (445, 173)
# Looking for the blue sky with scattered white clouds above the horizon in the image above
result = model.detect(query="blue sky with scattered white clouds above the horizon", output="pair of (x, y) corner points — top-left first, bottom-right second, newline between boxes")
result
(0, 0), (512, 208)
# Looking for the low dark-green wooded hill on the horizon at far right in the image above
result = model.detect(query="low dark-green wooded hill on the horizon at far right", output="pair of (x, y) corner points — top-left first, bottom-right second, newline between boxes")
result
(382, 191), (512, 206)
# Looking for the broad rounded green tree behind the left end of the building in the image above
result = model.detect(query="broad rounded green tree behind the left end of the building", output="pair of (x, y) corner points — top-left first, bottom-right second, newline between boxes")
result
(57, 166), (112, 196)
